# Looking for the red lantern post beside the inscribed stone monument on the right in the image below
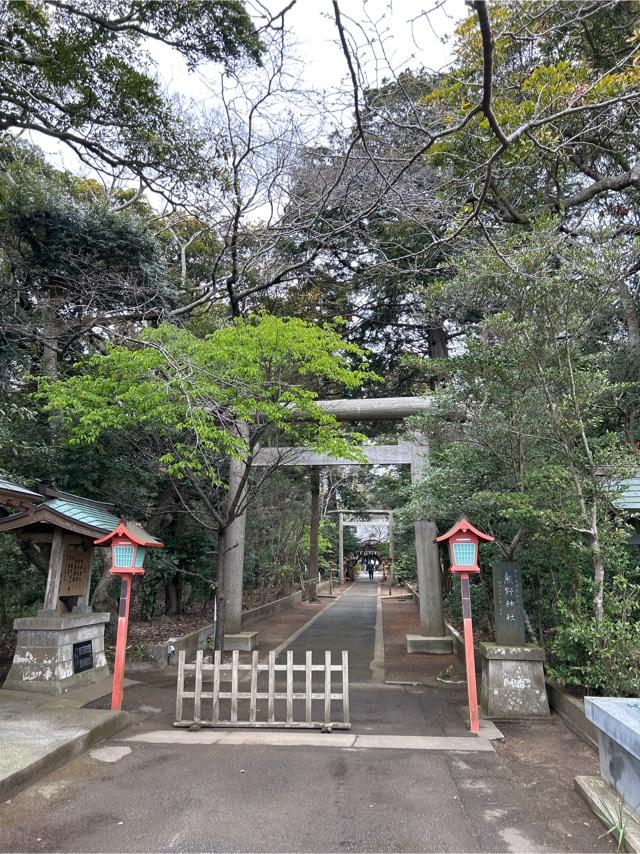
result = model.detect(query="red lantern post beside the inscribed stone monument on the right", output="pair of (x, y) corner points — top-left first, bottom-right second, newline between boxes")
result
(436, 519), (493, 733)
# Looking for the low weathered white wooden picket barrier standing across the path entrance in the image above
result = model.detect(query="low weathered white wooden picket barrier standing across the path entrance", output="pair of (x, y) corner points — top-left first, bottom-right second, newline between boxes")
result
(174, 650), (351, 729)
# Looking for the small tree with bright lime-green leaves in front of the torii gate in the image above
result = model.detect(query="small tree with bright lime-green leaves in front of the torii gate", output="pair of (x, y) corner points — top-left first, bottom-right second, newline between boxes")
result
(43, 315), (378, 645)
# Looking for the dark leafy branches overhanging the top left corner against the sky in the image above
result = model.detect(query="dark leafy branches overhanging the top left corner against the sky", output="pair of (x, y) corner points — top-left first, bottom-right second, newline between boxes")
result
(0, 0), (261, 185)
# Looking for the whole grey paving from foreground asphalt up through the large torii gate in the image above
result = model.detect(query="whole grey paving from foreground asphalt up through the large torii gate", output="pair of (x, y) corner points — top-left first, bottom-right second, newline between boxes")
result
(0, 578), (604, 852)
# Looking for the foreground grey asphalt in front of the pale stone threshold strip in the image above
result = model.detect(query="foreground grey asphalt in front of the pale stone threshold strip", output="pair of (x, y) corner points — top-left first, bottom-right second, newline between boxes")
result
(0, 741), (557, 852)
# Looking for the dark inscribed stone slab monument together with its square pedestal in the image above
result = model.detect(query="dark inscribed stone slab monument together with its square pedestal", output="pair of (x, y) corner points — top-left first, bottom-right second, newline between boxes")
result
(480, 561), (549, 720)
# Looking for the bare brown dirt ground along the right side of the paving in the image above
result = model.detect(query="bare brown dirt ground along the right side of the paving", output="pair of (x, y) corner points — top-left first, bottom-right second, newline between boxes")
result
(382, 598), (615, 852)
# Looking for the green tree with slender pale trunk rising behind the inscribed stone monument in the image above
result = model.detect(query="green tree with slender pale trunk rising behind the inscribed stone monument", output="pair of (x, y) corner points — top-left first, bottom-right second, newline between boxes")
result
(418, 228), (636, 620)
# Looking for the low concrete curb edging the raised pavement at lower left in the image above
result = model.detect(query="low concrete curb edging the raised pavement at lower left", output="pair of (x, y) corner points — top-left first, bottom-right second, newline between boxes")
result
(0, 712), (138, 800)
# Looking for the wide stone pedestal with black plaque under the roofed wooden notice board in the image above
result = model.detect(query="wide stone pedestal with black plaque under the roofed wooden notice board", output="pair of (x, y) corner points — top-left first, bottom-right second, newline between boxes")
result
(4, 609), (110, 694)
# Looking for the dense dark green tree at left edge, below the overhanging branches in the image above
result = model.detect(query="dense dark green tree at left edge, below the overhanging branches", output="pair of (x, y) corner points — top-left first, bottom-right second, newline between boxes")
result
(0, 145), (172, 382)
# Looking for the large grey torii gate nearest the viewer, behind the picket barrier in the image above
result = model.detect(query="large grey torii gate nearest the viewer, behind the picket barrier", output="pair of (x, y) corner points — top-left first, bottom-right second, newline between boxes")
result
(225, 397), (452, 653)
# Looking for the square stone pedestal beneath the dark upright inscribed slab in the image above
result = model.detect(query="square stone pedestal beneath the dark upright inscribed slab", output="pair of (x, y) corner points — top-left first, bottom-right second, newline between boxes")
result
(480, 643), (549, 720)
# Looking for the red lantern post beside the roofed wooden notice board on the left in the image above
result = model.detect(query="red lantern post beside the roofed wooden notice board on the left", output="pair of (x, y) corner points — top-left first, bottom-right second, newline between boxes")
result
(94, 519), (162, 712)
